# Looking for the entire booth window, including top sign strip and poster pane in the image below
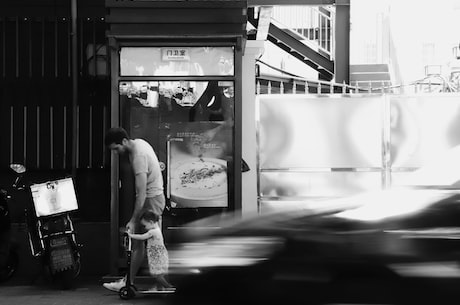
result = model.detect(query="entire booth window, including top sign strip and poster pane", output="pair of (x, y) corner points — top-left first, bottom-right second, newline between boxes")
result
(119, 46), (235, 209)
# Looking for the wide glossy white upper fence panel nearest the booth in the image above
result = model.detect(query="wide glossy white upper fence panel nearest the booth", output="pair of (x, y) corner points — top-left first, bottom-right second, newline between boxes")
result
(258, 94), (383, 169)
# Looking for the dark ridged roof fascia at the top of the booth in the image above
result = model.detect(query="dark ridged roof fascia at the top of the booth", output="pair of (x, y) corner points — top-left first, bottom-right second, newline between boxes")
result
(105, 0), (247, 38)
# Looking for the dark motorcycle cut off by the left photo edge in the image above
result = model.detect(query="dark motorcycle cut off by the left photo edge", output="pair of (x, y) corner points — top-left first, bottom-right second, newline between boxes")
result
(0, 165), (23, 282)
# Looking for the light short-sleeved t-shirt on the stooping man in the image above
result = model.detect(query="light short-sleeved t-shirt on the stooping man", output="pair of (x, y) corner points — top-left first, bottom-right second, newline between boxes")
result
(130, 139), (163, 198)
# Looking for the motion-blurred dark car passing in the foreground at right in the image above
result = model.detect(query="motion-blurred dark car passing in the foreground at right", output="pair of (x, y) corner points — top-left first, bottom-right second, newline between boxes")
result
(170, 188), (460, 304)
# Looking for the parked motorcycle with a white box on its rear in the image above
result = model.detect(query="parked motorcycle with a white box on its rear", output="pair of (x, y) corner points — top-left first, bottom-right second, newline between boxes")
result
(11, 164), (81, 289)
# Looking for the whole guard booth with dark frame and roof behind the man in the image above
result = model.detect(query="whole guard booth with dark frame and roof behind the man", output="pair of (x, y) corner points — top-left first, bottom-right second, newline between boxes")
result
(106, 0), (247, 275)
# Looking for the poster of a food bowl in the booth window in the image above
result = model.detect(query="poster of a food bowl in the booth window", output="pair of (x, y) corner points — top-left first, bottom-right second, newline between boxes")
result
(168, 122), (231, 208)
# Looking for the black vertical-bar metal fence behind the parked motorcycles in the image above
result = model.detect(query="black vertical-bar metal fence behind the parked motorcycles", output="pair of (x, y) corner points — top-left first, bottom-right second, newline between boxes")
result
(0, 17), (110, 169)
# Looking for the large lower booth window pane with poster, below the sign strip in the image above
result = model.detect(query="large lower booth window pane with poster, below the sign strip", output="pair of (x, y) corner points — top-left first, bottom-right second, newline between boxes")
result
(119, 80), (235, 208)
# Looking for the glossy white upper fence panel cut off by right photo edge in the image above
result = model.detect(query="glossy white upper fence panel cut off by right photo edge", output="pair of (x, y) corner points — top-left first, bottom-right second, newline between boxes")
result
(389, 94), (460, 168)
